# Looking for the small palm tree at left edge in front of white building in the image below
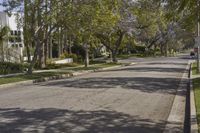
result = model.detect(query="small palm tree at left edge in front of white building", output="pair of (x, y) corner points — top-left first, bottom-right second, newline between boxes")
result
(0, 26), (10, 61)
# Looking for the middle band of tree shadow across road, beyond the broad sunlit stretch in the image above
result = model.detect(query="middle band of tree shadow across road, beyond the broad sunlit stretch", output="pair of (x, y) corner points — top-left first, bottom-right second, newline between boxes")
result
(42, 77), (187, 94)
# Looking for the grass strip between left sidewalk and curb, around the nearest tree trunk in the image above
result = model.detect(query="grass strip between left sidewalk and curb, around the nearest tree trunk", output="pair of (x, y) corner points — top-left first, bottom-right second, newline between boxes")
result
(0, 72), (68, 85)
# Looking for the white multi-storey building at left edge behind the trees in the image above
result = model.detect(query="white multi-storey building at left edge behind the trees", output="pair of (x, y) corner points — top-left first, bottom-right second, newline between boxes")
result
(0, 12), (24, 62)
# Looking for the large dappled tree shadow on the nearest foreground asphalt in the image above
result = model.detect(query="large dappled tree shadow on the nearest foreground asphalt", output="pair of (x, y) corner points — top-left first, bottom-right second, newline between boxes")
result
(0, 108), (181, 133)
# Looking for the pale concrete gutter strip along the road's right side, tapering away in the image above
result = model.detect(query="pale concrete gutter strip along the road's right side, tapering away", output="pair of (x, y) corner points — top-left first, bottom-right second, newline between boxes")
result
(163, 62), (189, 133)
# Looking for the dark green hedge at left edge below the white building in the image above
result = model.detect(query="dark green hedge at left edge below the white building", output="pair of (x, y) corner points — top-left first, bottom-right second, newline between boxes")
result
(0, 62), (25, 74)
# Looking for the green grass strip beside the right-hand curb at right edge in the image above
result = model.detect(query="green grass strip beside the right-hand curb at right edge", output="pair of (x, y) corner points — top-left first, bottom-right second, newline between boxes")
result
(192, 63), (200, 132)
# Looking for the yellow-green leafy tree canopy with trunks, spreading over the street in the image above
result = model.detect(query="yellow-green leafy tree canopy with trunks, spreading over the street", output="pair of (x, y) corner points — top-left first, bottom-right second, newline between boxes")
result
(1, 0), (194, 73)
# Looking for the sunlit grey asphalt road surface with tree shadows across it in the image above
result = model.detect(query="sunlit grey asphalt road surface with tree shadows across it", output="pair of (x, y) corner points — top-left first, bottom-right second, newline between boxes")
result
(0, 57), (188, 133)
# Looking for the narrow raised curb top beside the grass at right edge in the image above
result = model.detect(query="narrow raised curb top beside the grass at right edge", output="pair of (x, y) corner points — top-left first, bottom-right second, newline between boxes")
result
(189, 64), (198, 133)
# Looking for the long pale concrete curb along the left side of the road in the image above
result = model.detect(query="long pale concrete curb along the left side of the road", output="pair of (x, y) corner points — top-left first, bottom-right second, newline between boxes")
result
(0, 63), (137, 88)
